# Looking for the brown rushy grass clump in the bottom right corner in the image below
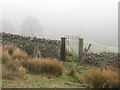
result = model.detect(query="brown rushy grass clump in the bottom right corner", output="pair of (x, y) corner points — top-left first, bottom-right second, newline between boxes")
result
(84, 69), (120, 88)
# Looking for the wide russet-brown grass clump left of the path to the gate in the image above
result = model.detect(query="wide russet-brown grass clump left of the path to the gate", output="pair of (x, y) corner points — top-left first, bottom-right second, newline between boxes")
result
(29, 58), (63, 76)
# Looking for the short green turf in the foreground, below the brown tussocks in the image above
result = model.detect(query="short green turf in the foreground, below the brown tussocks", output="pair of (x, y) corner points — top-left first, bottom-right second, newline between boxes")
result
(2, 62), (86, 88)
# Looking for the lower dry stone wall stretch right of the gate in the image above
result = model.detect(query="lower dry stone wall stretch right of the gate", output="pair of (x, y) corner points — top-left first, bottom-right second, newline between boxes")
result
(85, 52), (120, 68)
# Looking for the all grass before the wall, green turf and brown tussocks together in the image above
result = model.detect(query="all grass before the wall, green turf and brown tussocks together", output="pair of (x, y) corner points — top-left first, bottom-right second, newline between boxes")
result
(2, 45), (118, 88)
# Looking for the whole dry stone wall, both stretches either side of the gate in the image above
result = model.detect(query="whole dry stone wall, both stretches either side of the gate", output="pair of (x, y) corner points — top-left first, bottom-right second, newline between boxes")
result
(0, 33), (120, 66)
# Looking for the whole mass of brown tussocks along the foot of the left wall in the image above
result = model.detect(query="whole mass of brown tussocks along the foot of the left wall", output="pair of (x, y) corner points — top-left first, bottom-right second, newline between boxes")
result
(2, 45), (63, 76)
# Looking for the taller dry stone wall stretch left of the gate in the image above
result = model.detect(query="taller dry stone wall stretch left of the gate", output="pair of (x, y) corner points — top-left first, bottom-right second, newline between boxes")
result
(1, 33), (60, 58)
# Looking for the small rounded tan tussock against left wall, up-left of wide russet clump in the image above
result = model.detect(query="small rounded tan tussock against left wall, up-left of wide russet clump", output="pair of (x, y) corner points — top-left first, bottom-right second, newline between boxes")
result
(13, 48), (28, 60)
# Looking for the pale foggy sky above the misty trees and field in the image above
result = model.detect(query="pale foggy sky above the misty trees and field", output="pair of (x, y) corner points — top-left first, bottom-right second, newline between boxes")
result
(0, 0), (119, 46)
